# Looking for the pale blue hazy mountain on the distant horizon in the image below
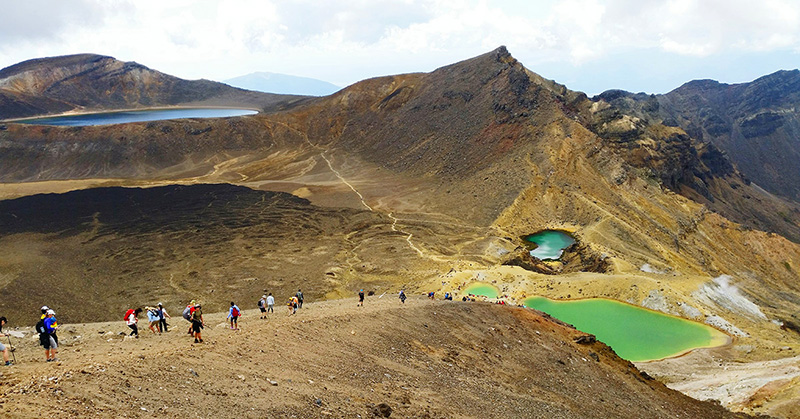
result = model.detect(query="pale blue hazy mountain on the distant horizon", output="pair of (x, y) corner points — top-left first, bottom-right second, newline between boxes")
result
(223, 72), (341, 96)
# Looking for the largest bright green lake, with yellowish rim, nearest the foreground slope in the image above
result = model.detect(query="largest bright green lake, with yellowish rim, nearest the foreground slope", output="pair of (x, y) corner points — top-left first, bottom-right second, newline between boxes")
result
(523, 297), (729, 362)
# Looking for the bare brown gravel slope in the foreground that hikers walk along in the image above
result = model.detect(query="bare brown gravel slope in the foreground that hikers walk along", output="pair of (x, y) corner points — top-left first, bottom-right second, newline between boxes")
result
(0, 294), (745, 418)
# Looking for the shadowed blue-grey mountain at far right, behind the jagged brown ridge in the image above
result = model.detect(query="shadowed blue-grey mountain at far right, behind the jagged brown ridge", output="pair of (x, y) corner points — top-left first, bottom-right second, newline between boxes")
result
(595, 70), (800, 201)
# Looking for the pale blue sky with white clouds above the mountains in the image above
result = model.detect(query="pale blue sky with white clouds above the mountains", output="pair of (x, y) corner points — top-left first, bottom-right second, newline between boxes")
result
(0, 0), (800, 94)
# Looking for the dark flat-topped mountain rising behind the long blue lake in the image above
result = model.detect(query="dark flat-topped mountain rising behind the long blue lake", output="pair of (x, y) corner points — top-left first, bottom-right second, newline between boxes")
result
(0, 54), (312, 119)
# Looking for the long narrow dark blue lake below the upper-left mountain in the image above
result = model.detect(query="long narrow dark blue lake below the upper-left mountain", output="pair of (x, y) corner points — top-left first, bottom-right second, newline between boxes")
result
(15, 108), (258, 127)
